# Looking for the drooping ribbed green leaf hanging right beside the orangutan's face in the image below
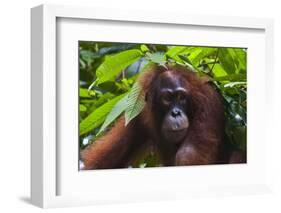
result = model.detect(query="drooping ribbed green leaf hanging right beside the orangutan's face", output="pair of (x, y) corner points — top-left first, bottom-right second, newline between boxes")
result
(125, 82), (145, 125)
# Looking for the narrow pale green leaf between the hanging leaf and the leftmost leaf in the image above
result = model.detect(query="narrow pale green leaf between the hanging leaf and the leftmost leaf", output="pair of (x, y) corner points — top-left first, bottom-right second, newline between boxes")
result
(97, 95), (128, 135)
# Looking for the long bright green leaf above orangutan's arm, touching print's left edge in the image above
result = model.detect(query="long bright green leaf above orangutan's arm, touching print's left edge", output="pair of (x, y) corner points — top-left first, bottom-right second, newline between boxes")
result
(80, 94), (125, 135)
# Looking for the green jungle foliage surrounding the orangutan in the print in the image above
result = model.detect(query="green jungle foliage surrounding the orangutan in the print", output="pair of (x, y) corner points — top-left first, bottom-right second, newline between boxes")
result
(79, 41), (247, 167)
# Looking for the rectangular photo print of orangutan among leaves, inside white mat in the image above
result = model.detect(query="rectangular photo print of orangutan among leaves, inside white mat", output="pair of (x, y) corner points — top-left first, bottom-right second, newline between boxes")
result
(78, 41), (247, 170)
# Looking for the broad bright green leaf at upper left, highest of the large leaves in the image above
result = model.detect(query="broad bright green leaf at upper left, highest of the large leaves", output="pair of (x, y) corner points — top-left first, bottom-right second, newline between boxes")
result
(95, 49), (142, 85)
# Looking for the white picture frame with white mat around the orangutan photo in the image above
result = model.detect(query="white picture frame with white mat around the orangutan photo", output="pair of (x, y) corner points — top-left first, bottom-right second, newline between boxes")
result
(31, 5), (273, 208)
